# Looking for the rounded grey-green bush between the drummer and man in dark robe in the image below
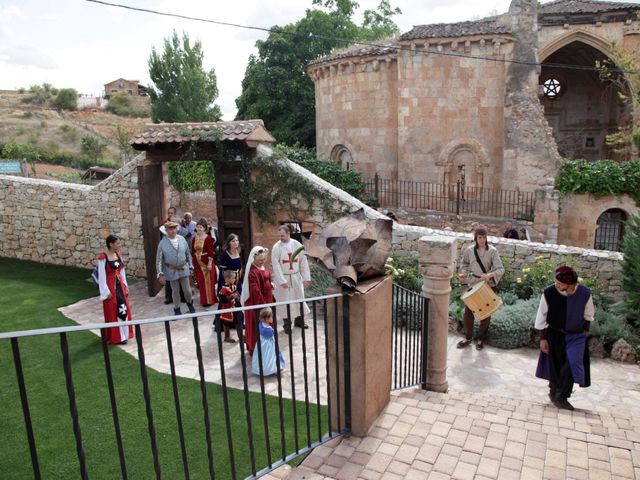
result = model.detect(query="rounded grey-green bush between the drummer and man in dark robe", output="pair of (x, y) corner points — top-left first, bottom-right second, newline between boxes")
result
(484, 298), (540, 349)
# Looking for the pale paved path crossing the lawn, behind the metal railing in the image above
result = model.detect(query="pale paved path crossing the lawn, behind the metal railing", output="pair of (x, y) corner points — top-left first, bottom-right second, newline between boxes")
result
(59, 282), (327, 404)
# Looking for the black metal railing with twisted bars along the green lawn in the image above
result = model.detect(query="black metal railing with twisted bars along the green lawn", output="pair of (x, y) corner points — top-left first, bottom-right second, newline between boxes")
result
(0, 294), (350, 479)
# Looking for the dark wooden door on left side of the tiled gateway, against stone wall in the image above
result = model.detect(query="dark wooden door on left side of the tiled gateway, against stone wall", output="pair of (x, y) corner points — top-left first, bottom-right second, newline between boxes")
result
(138, 163), (164, 297)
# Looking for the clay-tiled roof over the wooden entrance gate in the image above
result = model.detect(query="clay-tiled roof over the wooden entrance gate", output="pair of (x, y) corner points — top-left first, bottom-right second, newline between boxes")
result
(131, 120), (275, 149)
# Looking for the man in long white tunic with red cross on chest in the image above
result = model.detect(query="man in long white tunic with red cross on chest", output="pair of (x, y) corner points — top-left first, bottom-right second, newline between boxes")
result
(271, 225), (311, 333)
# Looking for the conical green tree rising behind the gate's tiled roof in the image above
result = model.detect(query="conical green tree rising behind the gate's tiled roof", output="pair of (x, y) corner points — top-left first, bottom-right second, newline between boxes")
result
(149, 31), (221, 122)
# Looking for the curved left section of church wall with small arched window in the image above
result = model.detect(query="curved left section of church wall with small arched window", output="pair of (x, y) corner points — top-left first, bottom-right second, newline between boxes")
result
(309, 57), (398, 178)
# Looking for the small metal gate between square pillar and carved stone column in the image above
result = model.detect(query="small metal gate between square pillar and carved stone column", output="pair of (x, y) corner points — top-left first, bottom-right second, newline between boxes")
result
(391, 284), (429, 390)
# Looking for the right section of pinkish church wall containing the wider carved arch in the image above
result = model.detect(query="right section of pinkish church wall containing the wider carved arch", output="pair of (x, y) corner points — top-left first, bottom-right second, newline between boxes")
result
(398, 38), (512, 188)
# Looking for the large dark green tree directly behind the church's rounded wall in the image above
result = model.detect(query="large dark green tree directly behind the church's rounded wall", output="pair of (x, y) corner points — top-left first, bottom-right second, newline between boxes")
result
(236, 0), (400, 147)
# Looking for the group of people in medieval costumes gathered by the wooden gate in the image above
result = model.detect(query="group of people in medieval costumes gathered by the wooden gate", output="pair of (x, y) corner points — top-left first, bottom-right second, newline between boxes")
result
(98, 207), (311, 375)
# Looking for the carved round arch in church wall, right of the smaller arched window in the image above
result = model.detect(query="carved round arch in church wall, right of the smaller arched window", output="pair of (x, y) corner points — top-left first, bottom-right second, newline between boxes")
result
(436, 138), (489, 188)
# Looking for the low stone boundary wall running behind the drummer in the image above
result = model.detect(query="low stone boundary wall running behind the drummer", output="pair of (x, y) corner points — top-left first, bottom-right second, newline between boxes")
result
(392, 223), (623, 300)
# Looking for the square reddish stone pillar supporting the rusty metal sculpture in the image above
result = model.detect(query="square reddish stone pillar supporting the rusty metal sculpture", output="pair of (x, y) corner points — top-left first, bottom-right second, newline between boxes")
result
(327, 277), (393, 436)
